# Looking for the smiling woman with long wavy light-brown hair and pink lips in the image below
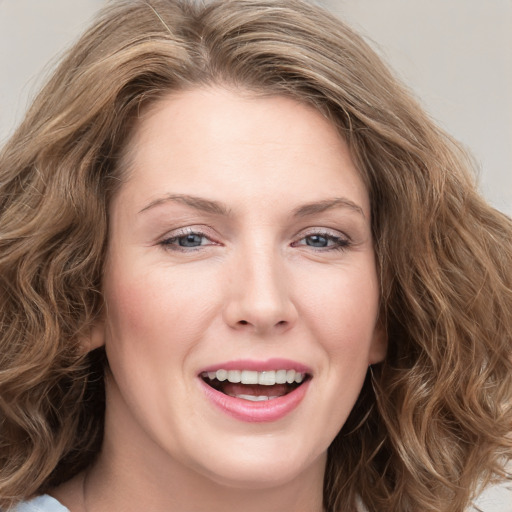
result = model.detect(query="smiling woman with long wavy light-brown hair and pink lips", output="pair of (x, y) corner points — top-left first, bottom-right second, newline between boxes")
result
(0, 0), (512, 512)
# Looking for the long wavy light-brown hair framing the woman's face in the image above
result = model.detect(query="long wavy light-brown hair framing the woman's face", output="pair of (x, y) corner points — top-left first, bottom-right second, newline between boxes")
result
(0, 0), (512, 512)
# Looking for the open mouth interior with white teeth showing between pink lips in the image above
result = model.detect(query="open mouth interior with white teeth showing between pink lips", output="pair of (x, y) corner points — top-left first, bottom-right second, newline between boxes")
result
(200, 369), (310, 402)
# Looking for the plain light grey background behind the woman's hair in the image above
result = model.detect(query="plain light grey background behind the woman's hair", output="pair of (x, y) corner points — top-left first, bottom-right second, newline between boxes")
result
(0, 0), (512, 512)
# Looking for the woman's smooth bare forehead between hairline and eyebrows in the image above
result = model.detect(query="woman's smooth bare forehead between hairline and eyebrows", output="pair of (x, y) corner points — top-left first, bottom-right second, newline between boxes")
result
(114, 88), (369, 216)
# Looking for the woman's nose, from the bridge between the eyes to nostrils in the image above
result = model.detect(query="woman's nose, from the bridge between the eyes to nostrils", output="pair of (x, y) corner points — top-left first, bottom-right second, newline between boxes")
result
(224, 247), (298, 335)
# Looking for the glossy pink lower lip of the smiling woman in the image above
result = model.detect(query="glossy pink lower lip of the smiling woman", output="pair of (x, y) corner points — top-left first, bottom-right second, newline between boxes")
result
(199, 377), (310, 423)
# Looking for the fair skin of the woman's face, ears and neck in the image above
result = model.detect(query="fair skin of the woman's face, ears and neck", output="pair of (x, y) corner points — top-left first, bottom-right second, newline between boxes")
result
(54, 88), (386, 512)
